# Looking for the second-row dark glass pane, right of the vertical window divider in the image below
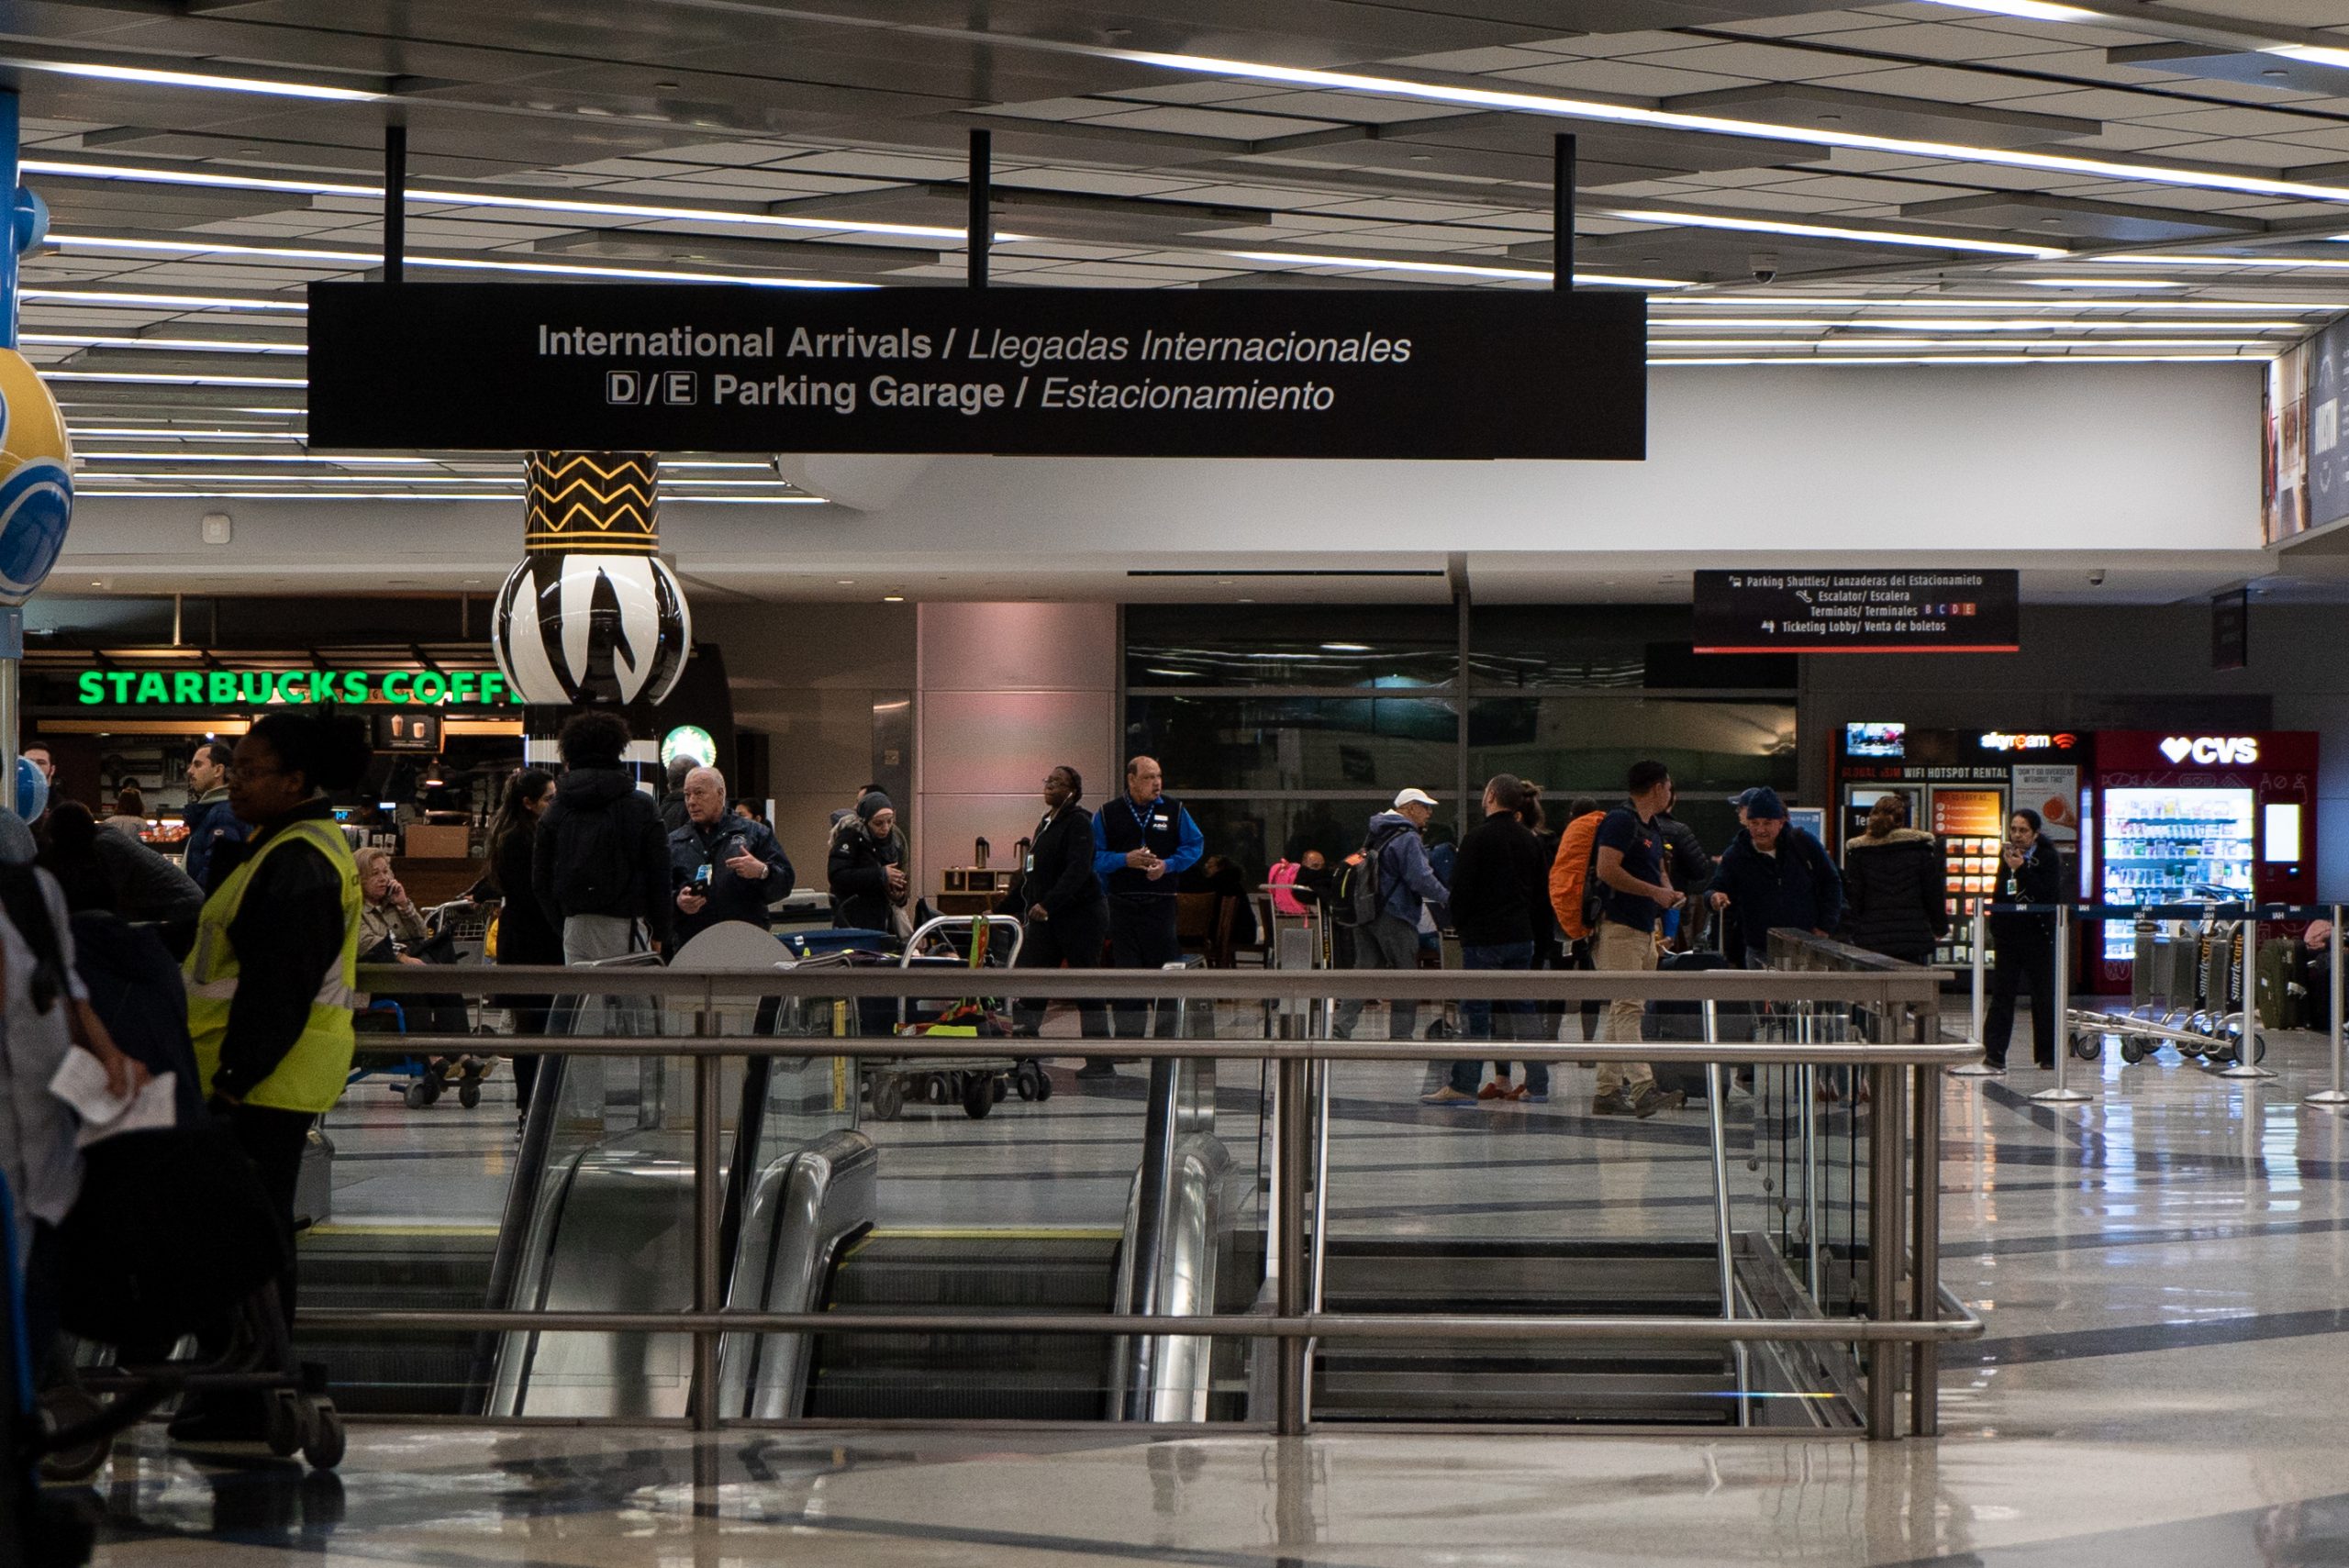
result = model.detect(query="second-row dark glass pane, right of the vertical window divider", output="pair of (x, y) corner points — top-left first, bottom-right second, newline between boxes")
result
(1468, 697), (1795, 803)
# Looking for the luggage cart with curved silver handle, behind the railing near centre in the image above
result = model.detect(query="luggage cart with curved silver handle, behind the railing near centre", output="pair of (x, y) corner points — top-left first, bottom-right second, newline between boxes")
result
(860, 916), (1052, 1122)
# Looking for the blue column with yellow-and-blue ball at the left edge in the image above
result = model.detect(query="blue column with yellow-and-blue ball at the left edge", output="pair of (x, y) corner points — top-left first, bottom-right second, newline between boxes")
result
(0, 92), (72, 758)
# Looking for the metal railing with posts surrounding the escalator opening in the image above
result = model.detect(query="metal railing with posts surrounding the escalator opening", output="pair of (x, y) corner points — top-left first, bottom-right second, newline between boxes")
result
(321, 964), (1983, 1439)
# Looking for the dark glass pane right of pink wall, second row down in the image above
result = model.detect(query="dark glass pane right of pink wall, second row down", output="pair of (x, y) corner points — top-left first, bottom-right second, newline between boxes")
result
(1125, 697), (1459, 795)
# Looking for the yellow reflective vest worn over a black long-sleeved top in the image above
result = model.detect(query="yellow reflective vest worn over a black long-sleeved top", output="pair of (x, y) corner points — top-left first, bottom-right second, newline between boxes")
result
(184, 817), (366, 1113)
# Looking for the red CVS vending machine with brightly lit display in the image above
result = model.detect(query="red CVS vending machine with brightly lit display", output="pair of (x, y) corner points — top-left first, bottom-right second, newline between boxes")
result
(2088, 730), (2316, 991)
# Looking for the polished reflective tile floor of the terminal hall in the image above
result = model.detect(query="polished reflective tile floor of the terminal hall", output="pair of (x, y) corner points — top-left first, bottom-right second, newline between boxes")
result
(68, 1009), (2349, 1568)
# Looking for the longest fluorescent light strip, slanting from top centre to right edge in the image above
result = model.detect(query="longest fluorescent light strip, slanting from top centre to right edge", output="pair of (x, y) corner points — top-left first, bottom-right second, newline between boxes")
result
(1113, 50), (2349, 205)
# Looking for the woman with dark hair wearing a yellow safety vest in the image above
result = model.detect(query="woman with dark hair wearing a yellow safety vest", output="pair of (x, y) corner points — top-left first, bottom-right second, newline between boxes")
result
(185, 714), (369, 1380)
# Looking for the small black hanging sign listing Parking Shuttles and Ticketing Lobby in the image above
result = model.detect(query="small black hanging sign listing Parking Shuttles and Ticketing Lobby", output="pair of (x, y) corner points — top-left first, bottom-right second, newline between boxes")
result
(1696, 571), (2021, 652)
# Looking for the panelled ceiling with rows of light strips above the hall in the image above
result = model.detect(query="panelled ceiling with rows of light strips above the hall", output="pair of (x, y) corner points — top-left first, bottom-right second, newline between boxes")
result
(0, 0), (2349, 490)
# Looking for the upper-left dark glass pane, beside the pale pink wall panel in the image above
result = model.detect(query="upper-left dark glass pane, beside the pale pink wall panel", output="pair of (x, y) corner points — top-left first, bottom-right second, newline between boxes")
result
(1125, 604), (1459, 688)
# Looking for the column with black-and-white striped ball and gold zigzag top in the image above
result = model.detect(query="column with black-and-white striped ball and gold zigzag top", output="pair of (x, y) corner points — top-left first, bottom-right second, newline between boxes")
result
(488, 450), (693, 706)
